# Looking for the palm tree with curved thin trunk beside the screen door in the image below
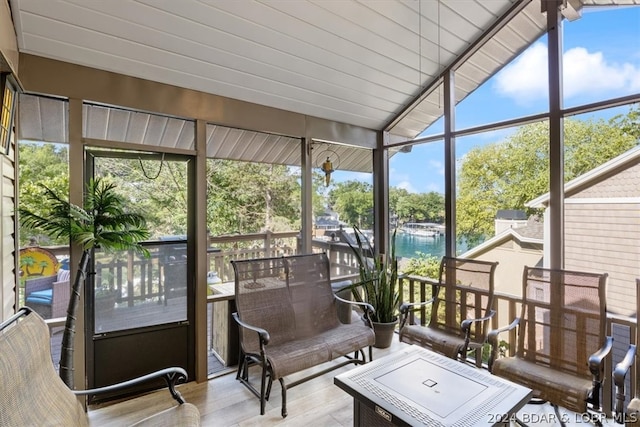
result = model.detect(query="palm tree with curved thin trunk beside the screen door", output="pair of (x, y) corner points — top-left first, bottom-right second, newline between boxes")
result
(19, 178), (149, 388)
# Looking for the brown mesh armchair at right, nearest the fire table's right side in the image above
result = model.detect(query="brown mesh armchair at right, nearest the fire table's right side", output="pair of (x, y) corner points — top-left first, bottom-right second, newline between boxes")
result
(489, 267), (613, 420)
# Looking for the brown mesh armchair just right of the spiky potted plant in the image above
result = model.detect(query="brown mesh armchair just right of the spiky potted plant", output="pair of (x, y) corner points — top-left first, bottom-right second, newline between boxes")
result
(400, 257), (498, 367)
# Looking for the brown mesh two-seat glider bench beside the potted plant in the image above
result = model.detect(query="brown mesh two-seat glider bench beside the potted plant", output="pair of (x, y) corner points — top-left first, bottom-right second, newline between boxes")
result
(232, 254), (375, 417)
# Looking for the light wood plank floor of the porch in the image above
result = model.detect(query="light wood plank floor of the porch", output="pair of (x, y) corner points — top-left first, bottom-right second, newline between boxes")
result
(89, 338), (618, 427)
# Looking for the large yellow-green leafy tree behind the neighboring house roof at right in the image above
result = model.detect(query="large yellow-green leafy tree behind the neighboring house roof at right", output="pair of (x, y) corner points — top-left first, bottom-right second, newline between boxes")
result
(456, 116), (640, 247)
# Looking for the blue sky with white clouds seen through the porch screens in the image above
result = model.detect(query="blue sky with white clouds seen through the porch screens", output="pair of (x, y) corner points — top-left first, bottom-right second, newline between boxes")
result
(334, 6), (640, 193)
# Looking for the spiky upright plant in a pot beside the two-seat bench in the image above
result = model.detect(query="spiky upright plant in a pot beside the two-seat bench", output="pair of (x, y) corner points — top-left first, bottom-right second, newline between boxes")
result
(349, 226), (400, 348)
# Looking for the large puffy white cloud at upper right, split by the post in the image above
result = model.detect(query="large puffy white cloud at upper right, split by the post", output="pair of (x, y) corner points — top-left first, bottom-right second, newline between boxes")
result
(495, 43), (640, 104)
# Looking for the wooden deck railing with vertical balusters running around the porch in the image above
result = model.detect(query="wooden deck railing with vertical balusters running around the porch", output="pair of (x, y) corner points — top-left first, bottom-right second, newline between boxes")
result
(26, 237), (637, 418)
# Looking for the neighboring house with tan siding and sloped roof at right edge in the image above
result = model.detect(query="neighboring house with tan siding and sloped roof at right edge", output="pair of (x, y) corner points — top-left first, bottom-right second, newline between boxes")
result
(527, 146), (640, 315)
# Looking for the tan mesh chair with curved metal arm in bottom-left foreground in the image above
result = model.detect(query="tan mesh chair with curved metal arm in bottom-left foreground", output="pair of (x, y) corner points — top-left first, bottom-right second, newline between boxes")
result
(0, 307), (200, 426)
